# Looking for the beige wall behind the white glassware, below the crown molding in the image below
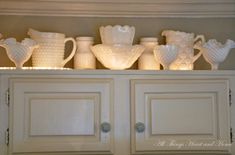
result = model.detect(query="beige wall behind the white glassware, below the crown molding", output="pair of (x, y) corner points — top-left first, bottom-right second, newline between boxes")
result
(0, 16), (235, 70)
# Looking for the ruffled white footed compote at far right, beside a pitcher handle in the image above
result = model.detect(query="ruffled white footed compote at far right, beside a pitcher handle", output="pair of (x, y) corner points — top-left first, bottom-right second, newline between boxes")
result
(202, 39), (235, 70)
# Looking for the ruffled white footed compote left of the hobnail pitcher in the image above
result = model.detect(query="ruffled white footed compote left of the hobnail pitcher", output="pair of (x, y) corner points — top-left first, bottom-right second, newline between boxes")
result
(0, 38), (38, 68)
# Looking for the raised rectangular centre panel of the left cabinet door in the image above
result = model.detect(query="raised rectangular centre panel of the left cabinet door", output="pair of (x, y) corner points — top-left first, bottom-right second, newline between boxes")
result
(29, 93), (96, 136)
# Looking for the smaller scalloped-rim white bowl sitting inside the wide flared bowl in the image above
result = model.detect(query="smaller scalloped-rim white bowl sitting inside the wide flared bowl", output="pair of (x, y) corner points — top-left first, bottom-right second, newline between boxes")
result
(100, 25), (135, 45)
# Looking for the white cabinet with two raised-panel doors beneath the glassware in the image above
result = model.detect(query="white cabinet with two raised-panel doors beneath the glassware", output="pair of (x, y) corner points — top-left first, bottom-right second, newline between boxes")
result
(0, 70), (235, 155)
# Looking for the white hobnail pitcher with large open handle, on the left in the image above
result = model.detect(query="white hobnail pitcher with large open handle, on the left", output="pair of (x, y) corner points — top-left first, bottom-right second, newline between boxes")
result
(28, 29), (76, 68)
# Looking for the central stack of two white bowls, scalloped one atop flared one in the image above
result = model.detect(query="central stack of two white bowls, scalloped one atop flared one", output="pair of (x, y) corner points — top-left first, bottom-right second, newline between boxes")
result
(91, 25), (144, 70)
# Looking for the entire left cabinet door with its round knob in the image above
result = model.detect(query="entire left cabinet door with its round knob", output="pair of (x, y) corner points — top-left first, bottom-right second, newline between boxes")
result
(10, 78), (113, 155)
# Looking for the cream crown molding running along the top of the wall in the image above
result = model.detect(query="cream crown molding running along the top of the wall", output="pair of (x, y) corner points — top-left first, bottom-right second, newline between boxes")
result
(0, 0), (235, 18)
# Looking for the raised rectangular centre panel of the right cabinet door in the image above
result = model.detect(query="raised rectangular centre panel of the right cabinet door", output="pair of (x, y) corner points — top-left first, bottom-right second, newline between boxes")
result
(151, 93), (216, 135)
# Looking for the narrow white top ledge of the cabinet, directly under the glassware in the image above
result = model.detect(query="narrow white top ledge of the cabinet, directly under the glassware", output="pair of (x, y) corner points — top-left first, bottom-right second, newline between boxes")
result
(0, 67), (235, 75)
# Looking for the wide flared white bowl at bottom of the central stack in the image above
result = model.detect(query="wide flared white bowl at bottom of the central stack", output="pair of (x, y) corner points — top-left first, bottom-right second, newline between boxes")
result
(91, 44), (144, 70)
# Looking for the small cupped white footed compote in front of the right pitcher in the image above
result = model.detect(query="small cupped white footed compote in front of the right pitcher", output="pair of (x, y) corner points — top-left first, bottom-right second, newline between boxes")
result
(153, 45), (179, 70)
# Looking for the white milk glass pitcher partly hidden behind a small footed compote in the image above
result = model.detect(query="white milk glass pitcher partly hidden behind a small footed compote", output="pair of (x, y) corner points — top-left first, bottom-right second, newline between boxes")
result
(162, 30), (205, 70)
